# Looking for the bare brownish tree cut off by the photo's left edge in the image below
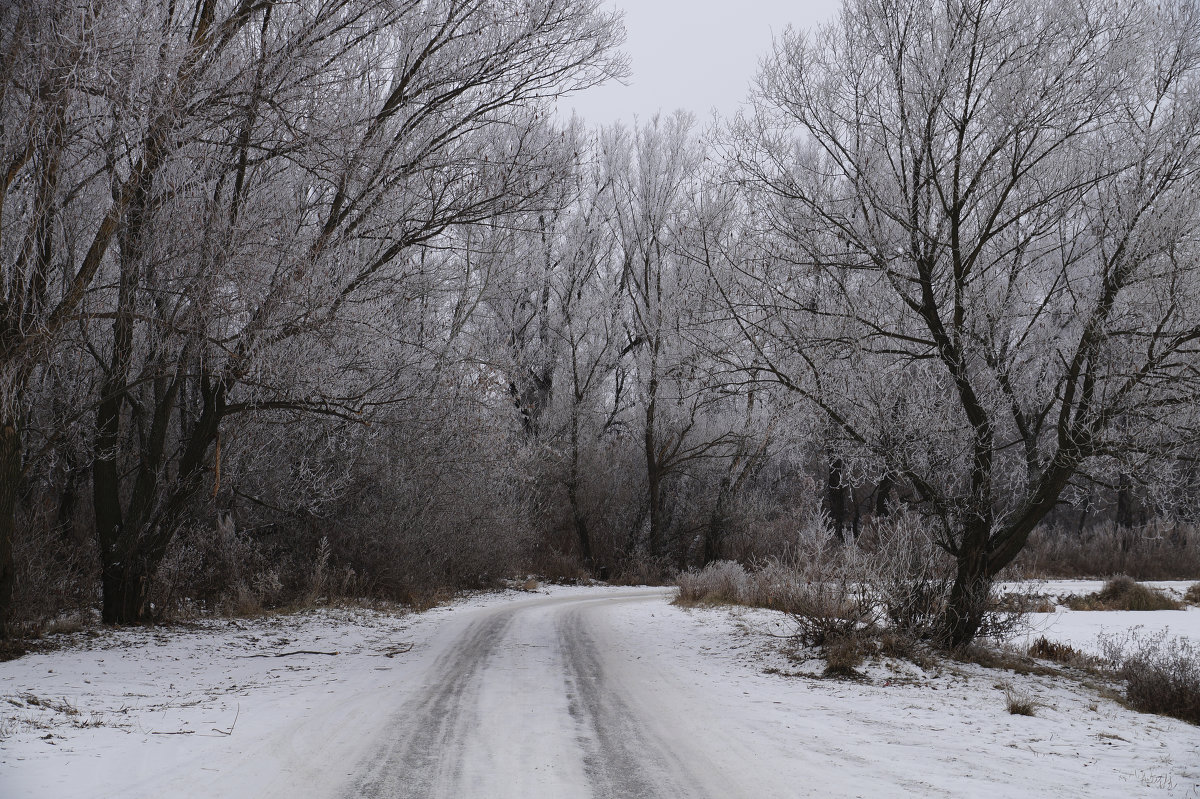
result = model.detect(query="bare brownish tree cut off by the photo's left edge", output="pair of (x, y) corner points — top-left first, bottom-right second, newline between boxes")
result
(0, 2), (136, 635)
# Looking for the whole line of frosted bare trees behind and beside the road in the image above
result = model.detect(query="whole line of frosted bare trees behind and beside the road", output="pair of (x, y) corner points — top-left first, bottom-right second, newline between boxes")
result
(7, 0), (1200, 642)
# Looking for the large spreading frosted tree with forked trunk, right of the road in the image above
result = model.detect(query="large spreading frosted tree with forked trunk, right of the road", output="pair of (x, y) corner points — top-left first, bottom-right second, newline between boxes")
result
(730, 0), (1200, 645)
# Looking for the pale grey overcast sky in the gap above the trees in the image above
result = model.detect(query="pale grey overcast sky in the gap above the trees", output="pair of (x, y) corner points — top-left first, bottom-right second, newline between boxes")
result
(559, 0), (839, 125)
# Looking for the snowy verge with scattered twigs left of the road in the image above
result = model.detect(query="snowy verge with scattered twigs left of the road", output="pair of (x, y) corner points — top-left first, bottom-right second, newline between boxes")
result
(0, 611), (420, 799)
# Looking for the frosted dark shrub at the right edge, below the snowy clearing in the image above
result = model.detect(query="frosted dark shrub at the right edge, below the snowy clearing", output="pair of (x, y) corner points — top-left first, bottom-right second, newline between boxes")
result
(1100, 631), (1200, 725)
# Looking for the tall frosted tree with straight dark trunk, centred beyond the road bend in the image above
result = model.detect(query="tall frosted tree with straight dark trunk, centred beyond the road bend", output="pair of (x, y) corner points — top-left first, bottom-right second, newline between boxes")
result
(601, 113), (753, 557)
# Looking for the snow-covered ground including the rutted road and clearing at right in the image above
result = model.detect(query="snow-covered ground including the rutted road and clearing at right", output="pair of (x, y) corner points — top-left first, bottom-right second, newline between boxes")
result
(0, 581), (1200, 799)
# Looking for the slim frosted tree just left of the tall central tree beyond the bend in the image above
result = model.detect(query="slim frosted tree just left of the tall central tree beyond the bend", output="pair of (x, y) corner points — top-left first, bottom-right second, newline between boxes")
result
(472, 135), (625, 559)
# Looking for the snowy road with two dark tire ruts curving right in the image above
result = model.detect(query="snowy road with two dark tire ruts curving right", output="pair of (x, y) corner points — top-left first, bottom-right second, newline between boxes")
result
(344, 590), (745, 799)
